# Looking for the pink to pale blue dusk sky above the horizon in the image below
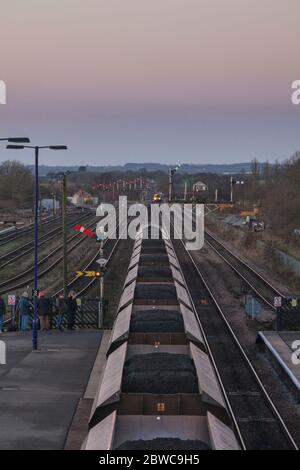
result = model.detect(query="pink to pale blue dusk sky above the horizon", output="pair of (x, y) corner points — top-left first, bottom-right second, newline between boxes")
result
(0, 0), (300, 165)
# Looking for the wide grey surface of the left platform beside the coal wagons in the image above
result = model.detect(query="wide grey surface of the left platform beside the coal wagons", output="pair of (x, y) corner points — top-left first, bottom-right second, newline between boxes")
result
(0, 330), (102, 450)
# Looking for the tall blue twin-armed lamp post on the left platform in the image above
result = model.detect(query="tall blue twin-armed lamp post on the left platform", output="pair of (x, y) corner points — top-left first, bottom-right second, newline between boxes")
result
(6, 145), (67, 351)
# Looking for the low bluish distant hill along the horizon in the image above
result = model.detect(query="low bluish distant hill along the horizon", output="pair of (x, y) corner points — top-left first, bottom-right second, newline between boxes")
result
(29, 162), (263, 176)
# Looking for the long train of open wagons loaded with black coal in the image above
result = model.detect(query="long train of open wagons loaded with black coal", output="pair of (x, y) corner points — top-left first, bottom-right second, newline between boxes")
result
(82, 231), (240, 450)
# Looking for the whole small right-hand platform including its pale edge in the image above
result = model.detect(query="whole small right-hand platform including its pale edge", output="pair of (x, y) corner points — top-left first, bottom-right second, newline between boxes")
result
(258, 331), (300, 402)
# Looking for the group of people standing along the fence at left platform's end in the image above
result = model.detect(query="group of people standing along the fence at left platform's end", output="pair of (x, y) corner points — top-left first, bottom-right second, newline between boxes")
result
(0, 291), (78, 332)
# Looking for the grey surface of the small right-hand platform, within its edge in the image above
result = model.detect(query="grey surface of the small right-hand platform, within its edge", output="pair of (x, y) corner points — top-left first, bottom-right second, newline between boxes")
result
(259, 331), (300, 391)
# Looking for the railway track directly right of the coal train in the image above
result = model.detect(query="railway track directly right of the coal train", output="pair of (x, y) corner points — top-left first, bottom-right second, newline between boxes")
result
(172, 240), (298, 450)
